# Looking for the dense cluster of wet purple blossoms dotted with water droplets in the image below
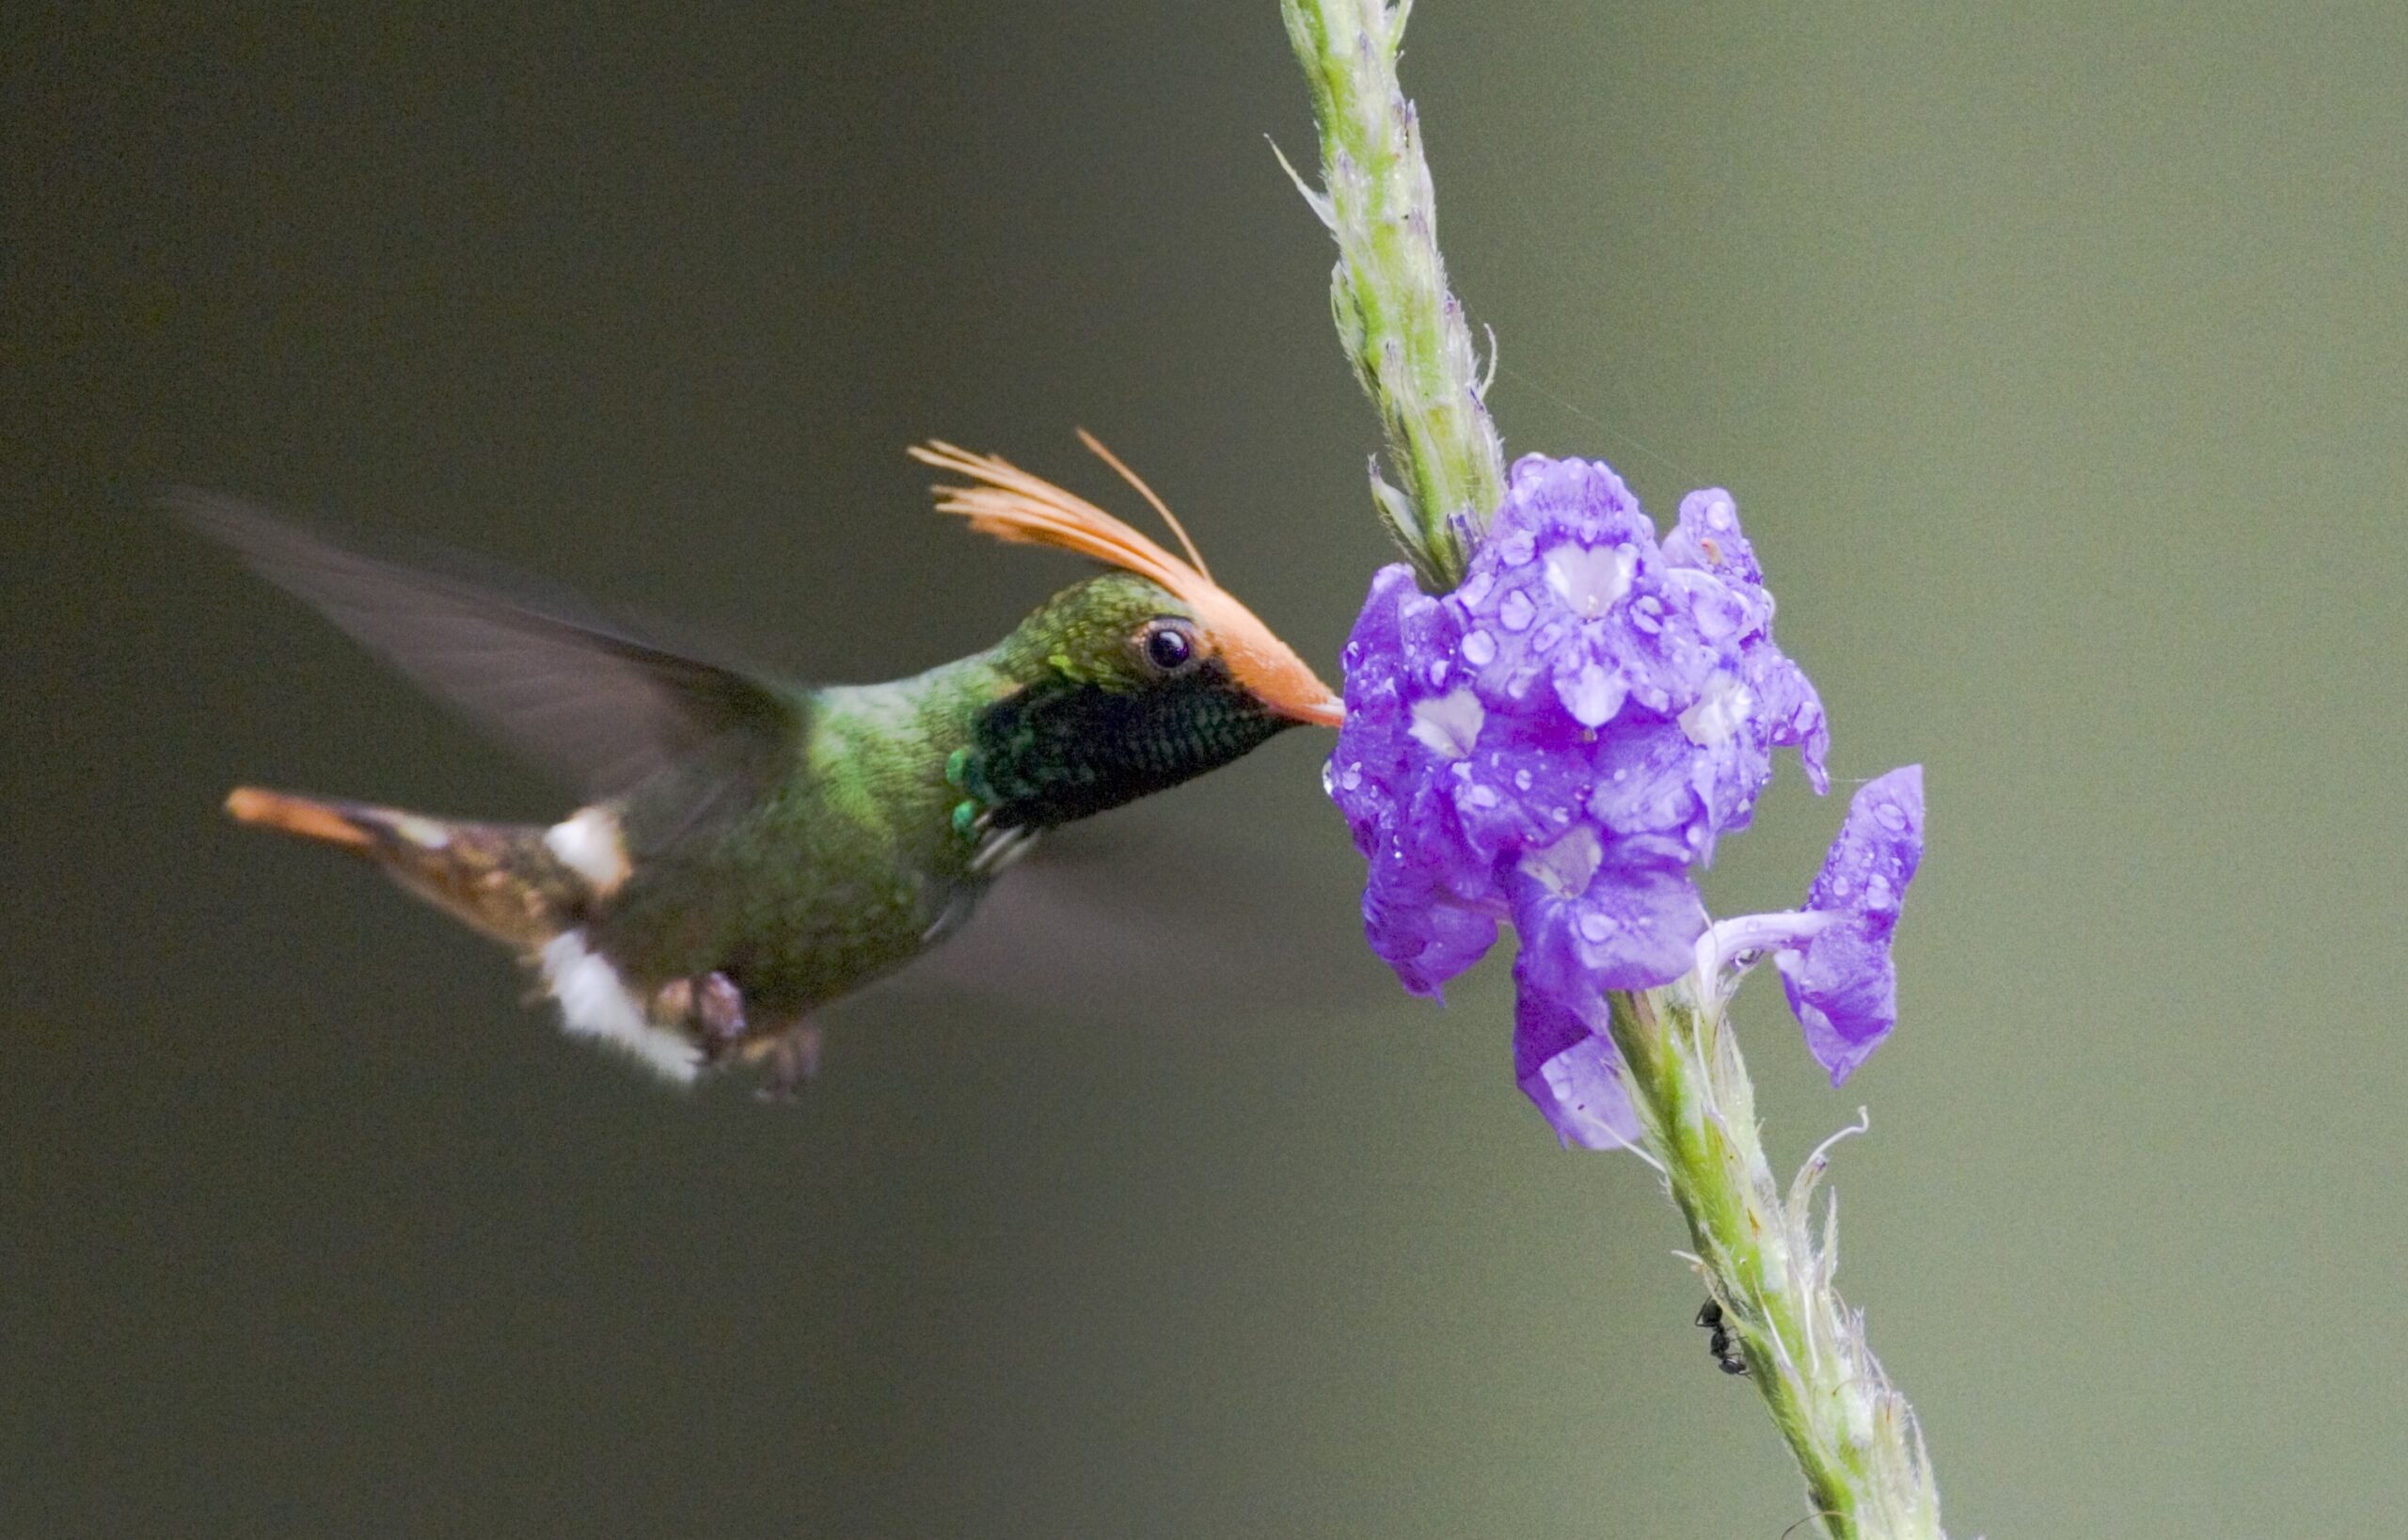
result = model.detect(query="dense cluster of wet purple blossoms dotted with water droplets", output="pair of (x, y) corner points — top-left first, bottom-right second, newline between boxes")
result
(1327, 455), (1922, 1145)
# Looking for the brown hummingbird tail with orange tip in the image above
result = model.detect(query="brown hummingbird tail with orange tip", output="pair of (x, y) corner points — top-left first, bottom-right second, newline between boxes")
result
(227, 786), (594, 952)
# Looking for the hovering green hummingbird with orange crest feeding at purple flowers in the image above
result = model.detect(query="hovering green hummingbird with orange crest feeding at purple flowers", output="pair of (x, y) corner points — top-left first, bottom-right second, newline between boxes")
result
(168, 429), (1343, 1097)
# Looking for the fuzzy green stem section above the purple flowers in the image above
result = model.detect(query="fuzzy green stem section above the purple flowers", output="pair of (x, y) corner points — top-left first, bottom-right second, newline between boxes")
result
(1281, 0), (1505, 593)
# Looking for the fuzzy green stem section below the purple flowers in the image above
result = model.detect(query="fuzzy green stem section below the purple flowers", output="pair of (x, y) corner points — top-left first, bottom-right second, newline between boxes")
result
(1607, 978), (1943, 1540)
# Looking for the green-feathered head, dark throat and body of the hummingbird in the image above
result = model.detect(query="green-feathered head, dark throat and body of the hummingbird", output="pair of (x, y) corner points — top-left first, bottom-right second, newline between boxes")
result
(593, 574), (1289, 1020)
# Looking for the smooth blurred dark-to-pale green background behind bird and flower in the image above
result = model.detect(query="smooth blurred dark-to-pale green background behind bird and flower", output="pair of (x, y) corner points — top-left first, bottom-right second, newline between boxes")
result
(0, 0), (2408, 1540)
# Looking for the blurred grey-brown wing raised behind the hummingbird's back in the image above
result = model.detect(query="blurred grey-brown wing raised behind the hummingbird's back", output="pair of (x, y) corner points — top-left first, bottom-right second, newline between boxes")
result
(166, 492), (801, 798)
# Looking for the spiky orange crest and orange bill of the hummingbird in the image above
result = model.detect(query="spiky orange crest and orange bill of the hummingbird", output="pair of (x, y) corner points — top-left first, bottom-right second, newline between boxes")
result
(911, 429), (1346, 728)
